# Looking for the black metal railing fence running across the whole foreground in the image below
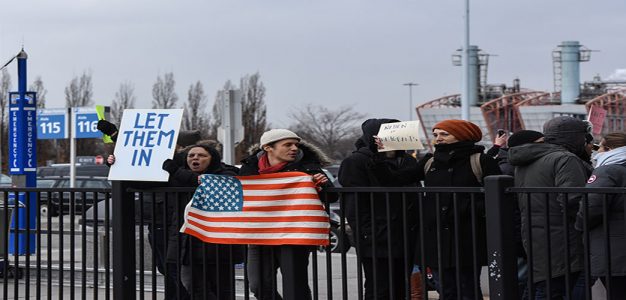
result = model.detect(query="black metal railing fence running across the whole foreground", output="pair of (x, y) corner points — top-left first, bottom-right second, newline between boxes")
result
(0, 176), (626, 299)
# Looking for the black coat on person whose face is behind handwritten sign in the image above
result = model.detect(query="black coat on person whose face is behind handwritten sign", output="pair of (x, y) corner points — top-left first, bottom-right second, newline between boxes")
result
(339, 147), (418, 258)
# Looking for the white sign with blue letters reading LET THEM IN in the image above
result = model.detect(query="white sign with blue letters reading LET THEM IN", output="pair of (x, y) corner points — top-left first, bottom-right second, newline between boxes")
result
(109, 109), (183, 181)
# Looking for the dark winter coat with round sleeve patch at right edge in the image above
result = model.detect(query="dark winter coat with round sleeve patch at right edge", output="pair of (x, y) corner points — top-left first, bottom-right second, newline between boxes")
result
(576, 164), (626, 276)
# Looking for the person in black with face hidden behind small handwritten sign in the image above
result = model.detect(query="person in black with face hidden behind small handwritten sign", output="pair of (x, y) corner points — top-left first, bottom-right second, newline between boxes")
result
(339, 119), (423, 300)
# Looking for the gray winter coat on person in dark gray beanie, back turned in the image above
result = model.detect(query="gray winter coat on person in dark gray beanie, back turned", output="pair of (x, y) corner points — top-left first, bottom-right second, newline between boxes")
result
(509, 143), (590, 282)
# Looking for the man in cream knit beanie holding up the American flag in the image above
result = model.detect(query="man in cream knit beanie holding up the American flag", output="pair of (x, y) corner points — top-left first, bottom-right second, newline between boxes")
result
(239, 129), (330, 300)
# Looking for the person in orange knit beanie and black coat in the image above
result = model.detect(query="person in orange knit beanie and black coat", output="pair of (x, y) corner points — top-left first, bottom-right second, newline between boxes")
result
(416, 120), (500, 299)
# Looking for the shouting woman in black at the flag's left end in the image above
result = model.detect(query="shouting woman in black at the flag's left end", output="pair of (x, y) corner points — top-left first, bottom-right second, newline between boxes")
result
(163, 145), (244, 299)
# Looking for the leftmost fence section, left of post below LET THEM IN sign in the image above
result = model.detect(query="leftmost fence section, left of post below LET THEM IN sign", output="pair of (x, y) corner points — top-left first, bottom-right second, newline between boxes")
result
(0, 188), (112, 299)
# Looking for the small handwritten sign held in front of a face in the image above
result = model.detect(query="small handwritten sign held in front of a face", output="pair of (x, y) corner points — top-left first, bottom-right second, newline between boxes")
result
(377, 121), (424, 152)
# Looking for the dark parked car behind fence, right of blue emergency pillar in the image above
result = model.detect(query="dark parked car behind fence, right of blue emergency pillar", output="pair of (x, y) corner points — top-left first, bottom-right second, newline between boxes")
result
(37, 176), (111, 216)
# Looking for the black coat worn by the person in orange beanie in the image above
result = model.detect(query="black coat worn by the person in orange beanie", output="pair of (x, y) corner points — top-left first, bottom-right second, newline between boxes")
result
(416, 142), (500, 268)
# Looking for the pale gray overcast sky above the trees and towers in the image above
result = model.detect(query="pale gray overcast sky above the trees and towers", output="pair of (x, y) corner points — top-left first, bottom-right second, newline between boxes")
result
(0, 0), (626, 127)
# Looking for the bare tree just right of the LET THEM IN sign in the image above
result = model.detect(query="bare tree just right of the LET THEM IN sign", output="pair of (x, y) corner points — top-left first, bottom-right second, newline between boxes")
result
(183, 81), (209, 132)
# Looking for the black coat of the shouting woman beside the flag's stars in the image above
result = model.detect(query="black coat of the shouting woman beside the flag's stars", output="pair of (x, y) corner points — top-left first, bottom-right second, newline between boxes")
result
(166, 151), (245, 264)
